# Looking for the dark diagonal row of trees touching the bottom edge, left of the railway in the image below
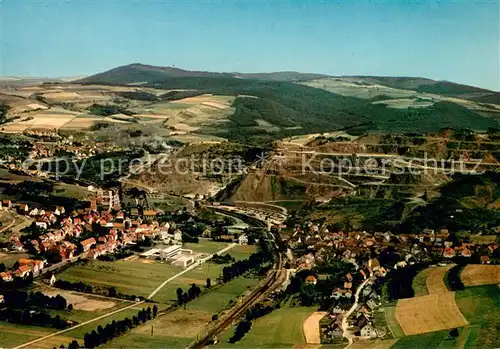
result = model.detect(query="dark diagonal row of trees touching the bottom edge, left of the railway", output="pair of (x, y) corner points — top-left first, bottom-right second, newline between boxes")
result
(61, 305), (158, 349)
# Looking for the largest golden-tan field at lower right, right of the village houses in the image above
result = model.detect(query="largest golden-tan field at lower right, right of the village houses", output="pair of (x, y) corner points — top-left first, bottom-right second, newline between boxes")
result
(396, 292), (468, 336)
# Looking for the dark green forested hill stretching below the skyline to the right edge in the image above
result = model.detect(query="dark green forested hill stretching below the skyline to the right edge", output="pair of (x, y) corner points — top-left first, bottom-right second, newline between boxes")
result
(76, 66), (498, 141)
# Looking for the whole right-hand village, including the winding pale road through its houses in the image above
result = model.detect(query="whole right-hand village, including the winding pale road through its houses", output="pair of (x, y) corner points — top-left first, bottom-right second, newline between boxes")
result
(287, 222), (500, 343)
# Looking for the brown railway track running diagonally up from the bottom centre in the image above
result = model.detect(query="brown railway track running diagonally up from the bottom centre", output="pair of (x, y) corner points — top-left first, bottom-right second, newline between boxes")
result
(187, 254), (286, 349)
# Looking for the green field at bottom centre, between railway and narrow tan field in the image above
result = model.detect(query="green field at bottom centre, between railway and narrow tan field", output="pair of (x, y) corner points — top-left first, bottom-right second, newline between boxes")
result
(218, 307), (316, 348)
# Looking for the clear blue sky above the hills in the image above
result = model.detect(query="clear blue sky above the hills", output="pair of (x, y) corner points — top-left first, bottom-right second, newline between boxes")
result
(0, 0), (500, 91)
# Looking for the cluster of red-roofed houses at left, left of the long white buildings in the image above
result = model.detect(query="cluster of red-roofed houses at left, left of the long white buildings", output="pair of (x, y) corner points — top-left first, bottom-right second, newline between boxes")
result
(0, 189), (170, 282)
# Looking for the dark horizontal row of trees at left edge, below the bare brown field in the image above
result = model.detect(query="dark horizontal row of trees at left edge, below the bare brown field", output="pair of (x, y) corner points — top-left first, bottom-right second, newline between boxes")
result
(3, 290), (69, 310)
